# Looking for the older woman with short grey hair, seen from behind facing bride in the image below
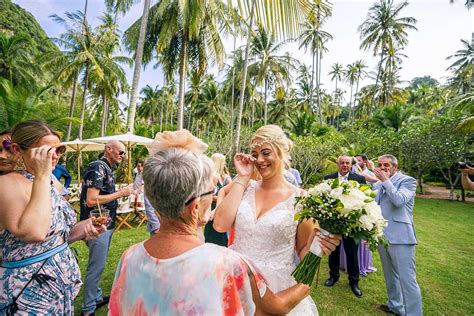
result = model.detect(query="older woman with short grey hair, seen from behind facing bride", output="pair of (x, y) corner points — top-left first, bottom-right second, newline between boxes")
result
(109, 142), (309, 315)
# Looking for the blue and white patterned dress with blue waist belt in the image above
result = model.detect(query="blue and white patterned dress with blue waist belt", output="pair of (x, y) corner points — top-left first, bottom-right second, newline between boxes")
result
(0, 173), (82, 315)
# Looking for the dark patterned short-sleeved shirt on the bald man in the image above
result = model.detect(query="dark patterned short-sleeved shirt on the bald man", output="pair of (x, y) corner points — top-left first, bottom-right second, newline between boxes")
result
(81, 157), (118, 229)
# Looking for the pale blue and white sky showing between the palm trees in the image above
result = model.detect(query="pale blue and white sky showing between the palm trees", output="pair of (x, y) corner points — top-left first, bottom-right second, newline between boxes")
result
(13, 0), (474, 103)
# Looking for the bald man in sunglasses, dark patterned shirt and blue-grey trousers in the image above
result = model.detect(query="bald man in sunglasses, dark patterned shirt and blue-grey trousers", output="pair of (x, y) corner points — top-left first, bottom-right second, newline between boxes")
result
(80, 141), (133, 315)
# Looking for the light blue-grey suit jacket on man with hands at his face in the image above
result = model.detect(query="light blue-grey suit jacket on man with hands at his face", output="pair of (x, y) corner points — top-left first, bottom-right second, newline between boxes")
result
(373, 172), (418, 245)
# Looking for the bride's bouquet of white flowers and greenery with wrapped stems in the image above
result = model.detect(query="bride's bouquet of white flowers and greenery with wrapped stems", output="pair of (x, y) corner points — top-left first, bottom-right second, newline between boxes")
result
(291, 179), (387, 285)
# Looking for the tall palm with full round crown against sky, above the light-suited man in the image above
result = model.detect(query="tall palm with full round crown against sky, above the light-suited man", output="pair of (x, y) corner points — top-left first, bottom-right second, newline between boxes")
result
(359, 0), (417, 107)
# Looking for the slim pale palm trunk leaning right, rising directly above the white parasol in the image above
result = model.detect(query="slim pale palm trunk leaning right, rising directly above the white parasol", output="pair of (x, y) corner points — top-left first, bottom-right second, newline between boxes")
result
(127, 0), (150, 133)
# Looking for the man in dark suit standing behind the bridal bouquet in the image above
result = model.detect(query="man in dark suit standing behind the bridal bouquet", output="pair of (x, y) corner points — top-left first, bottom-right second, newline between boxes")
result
(324, 156), (366, 297)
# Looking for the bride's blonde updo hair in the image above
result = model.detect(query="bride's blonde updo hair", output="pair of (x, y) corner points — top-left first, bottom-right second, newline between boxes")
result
(250, 125), (293, 169)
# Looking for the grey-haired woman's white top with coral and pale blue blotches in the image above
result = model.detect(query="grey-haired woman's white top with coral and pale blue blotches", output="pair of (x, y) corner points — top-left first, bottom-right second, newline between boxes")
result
(109, 242), (266, 316)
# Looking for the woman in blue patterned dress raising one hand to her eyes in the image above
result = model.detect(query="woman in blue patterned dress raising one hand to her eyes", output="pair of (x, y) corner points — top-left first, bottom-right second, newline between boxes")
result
(0, 121), (105, 315)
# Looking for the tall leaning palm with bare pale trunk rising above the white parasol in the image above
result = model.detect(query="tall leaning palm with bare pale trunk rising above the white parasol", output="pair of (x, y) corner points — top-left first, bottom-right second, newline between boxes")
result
(105, 0), (151, 133)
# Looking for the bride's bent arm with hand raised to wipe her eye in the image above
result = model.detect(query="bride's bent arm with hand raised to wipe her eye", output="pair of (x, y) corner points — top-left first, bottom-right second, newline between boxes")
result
(213, 154), (255, 233)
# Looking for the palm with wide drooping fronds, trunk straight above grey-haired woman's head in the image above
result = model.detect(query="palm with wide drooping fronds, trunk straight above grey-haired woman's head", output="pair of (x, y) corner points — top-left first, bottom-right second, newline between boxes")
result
(125, 0), (225, 129)
